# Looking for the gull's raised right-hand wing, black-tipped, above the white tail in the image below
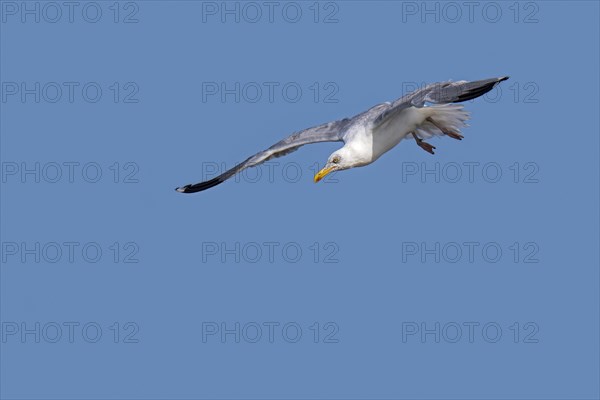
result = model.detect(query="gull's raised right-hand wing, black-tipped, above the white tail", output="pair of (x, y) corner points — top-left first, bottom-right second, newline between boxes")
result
(374, 76), (508, 126)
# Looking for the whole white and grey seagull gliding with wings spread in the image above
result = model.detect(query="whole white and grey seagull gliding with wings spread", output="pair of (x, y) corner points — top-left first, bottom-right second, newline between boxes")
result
(175, 76), (508, 193)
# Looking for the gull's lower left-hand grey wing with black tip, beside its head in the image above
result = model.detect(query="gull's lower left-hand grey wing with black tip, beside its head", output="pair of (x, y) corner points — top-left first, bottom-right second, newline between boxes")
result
(175, 118), (351, 193)
